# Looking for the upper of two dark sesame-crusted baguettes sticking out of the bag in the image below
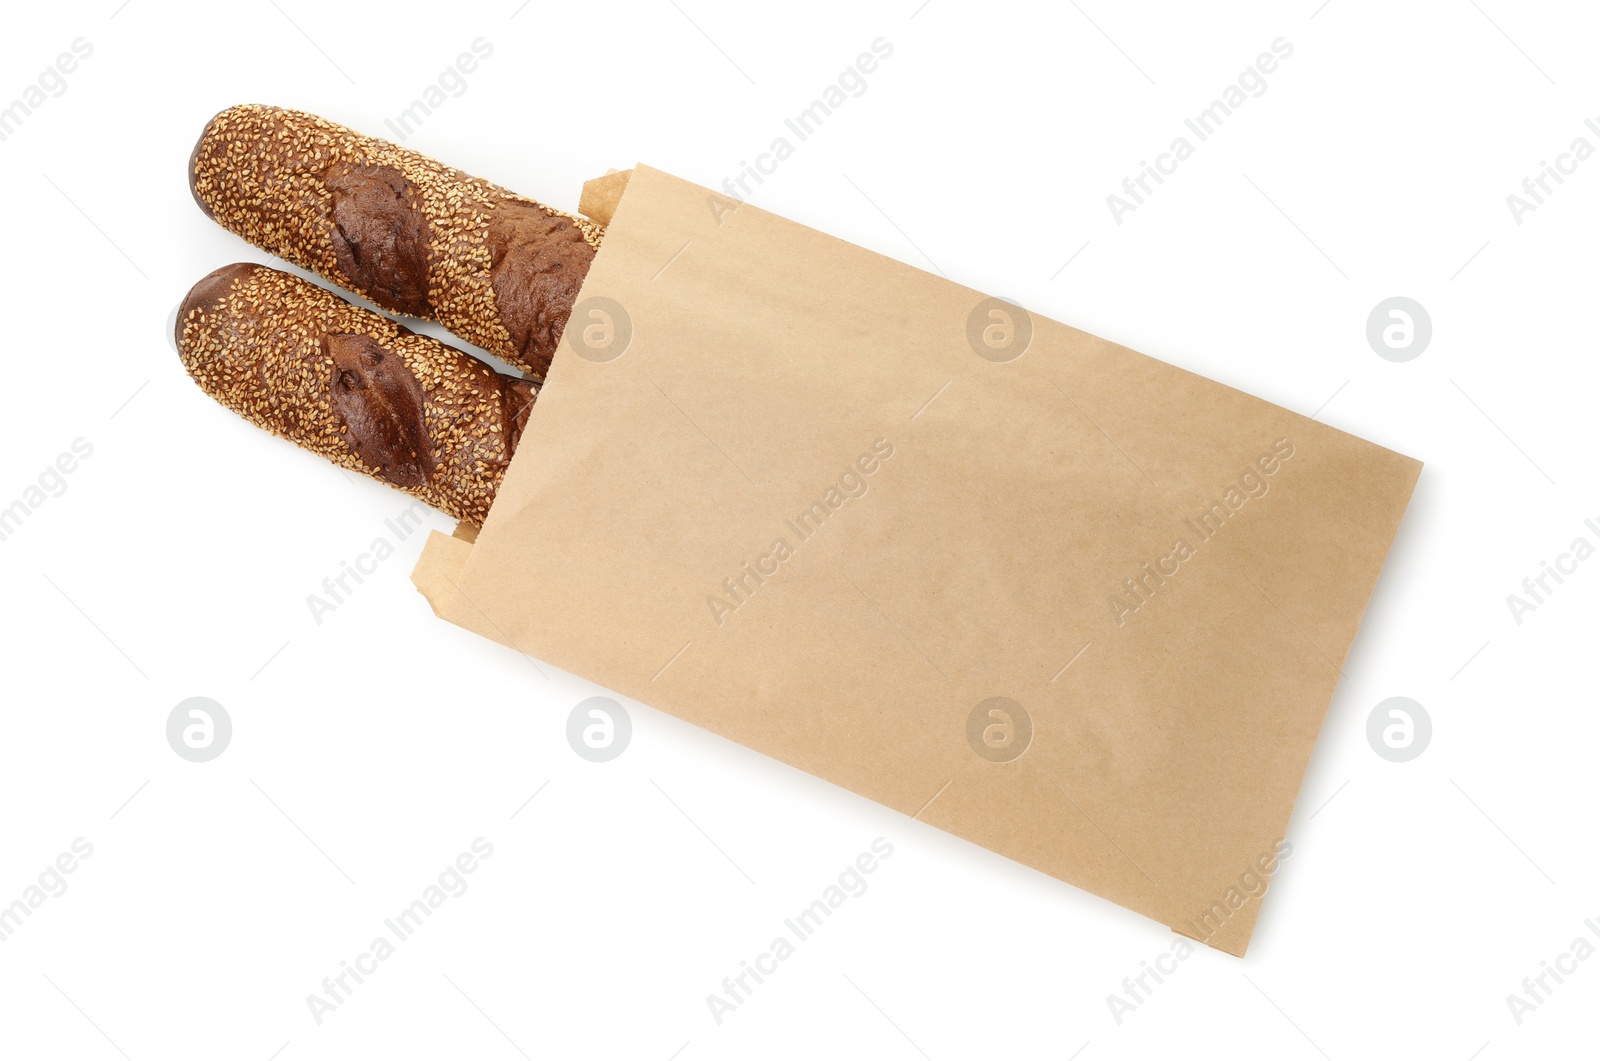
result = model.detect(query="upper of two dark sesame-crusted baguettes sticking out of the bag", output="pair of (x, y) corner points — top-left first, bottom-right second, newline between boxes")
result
(189, 104), (603, 379)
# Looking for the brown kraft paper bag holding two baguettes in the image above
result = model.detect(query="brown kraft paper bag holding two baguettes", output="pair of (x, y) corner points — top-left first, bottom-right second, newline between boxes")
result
(414, 166), (1421, 954)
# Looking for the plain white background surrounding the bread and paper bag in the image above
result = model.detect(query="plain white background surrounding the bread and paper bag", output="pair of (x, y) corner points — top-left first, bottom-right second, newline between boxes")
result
(0, 0), (1600, 1061)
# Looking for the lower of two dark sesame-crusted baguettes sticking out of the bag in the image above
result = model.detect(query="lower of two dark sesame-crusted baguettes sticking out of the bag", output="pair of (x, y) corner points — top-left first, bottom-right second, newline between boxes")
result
(174, 262), (536, 525)
